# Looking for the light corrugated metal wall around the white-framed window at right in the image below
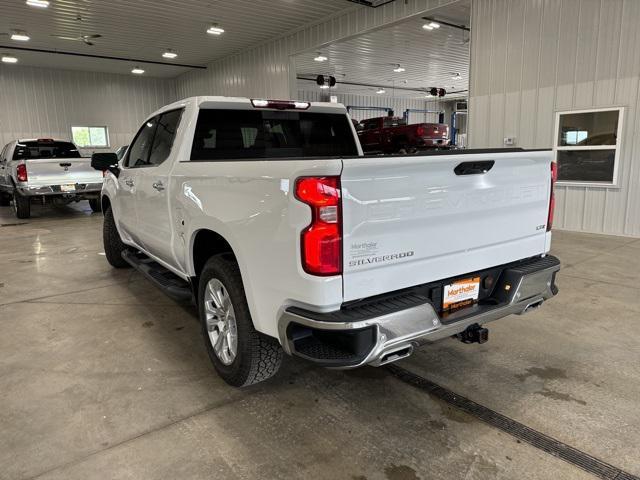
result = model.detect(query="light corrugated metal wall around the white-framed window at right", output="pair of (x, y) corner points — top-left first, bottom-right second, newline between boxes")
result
(469, 0), (640, 236)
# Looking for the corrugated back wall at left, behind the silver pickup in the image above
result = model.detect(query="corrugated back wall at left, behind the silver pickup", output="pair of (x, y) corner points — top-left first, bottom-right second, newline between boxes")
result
(0, 65), (175, 153)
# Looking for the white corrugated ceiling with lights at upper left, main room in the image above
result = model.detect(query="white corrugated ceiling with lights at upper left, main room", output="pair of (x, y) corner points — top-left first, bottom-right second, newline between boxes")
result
(0, 0), (356, 76)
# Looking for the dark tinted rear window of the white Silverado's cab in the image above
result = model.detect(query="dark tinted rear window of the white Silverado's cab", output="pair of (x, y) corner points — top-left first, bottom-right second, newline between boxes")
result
(191, 109), (358, 160)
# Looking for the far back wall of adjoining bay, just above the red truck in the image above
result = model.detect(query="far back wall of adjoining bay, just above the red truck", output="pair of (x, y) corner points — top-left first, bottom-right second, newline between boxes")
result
(297, 90), (443, 123)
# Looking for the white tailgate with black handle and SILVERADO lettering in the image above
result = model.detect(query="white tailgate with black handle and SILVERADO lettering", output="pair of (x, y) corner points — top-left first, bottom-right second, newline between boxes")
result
(341, 151), (552, 301)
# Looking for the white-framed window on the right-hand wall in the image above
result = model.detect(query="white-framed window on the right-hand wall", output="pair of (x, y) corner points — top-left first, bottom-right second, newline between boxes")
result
(554, 108), (623, 186)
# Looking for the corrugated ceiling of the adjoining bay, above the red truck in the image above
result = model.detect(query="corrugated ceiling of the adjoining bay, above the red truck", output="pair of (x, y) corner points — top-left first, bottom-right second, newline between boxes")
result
(295, 1), (470, 97)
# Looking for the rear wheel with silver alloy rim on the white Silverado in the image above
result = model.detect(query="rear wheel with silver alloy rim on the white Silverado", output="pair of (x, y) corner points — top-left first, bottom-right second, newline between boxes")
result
(198, 255), (283, 387)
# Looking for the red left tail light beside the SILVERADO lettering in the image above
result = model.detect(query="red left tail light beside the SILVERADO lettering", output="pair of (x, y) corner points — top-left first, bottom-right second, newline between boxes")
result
(296, 177), (342, 276)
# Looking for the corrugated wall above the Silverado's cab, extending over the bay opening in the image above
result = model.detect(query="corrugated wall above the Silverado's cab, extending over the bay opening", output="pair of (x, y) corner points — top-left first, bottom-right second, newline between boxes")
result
(177, 0), (455, 98)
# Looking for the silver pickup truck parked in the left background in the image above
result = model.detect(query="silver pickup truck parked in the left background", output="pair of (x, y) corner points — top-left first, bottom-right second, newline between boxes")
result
(0, 138), (102, 218)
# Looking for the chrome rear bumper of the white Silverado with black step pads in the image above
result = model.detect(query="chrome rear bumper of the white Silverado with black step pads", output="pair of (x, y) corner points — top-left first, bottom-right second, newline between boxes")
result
(278, 256), (560, 368)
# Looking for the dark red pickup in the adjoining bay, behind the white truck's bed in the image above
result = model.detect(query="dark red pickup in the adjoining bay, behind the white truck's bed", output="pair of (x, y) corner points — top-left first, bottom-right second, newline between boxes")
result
(357, 117), (450, 153)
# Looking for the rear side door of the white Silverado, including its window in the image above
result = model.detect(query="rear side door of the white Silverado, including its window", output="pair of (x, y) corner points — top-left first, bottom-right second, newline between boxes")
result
(136, 109), (182, 267)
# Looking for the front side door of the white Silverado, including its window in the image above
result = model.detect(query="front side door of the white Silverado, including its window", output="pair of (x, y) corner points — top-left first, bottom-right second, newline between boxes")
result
(113, 117), (158, 246)
